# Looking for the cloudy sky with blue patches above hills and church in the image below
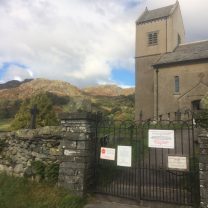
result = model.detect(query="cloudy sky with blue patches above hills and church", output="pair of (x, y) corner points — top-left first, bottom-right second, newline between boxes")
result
(0, 0), (208, 87)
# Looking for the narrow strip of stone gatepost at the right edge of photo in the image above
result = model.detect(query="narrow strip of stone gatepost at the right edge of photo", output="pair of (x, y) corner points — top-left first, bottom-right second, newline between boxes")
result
(199, 130), (208, 208)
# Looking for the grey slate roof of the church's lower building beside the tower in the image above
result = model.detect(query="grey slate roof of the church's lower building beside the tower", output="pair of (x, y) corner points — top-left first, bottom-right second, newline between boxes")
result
(154, 40), (208, 66)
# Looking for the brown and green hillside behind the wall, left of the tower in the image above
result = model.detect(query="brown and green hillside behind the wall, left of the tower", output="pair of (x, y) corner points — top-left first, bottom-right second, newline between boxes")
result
(0, 79), (134, 125)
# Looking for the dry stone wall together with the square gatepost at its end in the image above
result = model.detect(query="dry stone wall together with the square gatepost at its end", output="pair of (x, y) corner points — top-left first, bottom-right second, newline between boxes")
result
(0, 113), (96, 195)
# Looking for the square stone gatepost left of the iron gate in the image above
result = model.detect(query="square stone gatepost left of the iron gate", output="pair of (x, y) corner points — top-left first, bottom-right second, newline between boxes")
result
(59, 113), (96, 196)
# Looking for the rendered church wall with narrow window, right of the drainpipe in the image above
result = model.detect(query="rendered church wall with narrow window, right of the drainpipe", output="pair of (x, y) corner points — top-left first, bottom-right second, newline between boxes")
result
(155, 63), (208, 115)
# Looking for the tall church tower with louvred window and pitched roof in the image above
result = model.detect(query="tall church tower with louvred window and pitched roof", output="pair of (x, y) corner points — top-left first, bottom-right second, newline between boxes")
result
(135, 1), (185, 121)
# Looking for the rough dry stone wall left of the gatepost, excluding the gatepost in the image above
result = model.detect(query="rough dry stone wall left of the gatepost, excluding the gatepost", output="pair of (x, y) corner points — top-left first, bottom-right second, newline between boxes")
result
(0, 127), (62, 177)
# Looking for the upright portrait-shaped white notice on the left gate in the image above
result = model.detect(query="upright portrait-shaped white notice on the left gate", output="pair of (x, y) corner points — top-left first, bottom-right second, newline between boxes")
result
(117, 146), (132, 167)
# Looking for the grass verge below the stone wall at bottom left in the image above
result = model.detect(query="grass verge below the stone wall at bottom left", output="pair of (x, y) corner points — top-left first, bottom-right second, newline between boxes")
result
(0, 174), (85, 208)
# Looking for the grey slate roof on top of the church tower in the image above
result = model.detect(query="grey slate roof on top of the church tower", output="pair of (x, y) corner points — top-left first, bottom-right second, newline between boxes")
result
(136, 3), (177, 24)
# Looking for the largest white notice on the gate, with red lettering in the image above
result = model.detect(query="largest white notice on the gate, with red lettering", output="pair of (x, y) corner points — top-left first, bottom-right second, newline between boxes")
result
(148, 129), (174, 149)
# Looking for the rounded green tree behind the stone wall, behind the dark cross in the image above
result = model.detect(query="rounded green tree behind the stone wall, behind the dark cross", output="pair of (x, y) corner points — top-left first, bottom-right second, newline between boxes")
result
(11, 93), (58, 130)
